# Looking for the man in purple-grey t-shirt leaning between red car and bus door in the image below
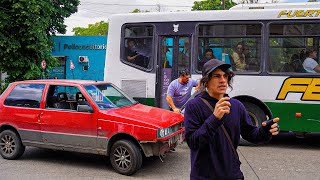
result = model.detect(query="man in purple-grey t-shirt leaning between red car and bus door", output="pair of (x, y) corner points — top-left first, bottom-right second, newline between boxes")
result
(166, 70), (199, 113)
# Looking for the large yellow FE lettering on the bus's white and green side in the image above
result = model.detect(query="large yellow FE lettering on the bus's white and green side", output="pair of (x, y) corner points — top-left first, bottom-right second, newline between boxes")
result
(277, 78), (320, 101)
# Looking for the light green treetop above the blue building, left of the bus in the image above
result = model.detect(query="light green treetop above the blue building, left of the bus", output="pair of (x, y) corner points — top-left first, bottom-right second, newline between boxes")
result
(72, 21), (109, 36)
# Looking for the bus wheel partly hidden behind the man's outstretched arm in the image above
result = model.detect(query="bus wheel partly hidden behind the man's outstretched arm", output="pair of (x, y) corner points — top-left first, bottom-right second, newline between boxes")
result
(239, 102), (266, 146)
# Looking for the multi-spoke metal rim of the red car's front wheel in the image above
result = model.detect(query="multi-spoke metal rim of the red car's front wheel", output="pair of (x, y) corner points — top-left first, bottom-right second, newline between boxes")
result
(114, 146), (131, 169)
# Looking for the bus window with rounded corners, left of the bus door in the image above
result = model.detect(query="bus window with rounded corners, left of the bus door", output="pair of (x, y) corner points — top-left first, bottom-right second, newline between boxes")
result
(121, 25), (153, 70)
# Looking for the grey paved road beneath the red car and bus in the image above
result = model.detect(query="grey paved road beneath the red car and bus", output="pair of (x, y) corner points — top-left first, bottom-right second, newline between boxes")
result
(0, 134), (320, 180)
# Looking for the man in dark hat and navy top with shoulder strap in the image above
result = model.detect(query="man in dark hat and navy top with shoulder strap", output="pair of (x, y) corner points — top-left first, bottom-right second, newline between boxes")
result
(184, 59), (279, 180)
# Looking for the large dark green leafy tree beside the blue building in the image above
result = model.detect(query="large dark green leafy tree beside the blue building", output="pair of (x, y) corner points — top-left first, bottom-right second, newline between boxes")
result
(0, 0), (80, 82)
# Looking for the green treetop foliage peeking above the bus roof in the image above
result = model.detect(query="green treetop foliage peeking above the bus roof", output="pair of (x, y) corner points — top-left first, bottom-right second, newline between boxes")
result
(192, 0), (236, 11)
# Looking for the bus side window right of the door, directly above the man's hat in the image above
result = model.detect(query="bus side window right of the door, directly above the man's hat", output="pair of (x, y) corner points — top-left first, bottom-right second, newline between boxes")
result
(196, 24), (262, 73)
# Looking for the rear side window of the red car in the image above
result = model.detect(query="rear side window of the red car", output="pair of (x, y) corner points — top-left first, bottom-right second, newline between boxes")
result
(4, 84), (45, 108)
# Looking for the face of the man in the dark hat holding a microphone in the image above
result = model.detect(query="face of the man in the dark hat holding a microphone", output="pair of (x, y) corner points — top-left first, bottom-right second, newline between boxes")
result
(207, 69), (228, 95)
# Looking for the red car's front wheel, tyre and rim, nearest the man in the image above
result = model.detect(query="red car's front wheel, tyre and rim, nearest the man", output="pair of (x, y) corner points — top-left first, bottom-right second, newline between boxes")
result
(110, 140), (142, 176)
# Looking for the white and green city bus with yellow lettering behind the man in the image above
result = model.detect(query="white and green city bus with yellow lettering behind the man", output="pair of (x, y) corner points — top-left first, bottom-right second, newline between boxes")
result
(104, 3), (320, 135)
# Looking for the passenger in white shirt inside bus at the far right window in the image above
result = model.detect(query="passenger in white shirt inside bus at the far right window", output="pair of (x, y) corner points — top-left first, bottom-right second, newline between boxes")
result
(302, 48), (320, 73)
